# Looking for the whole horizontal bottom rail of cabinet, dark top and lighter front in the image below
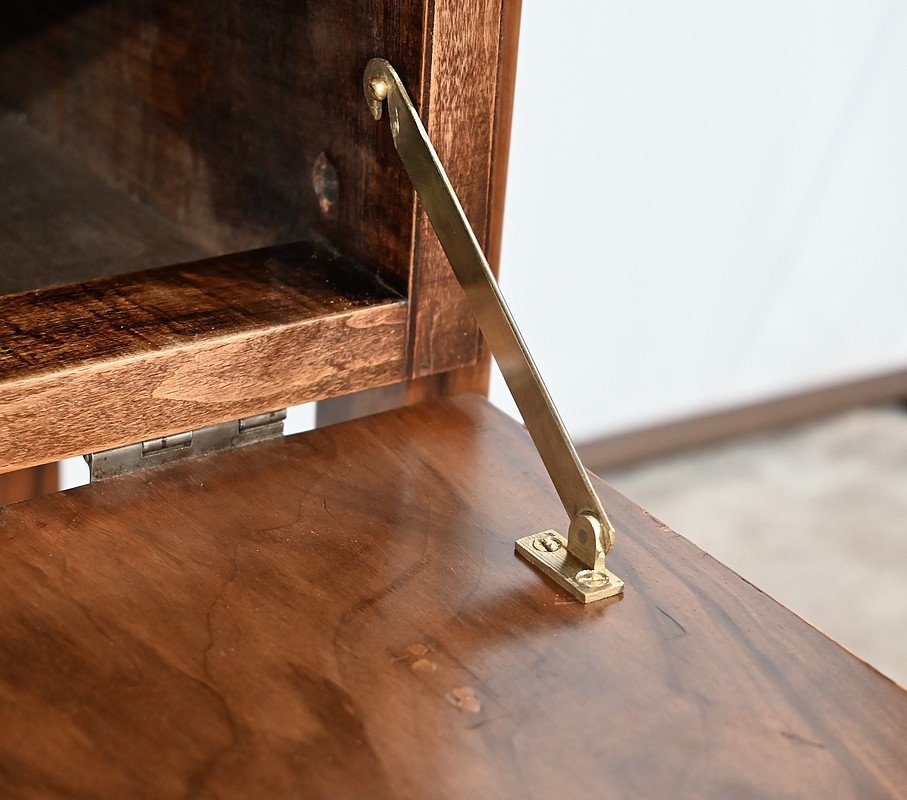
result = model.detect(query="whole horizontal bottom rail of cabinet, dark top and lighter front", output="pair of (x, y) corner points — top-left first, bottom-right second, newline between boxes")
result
(0, 244), (406, 472)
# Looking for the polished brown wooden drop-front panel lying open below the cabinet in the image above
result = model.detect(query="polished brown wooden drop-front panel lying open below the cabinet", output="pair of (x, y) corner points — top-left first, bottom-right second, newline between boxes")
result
(0, 398), (907, 800)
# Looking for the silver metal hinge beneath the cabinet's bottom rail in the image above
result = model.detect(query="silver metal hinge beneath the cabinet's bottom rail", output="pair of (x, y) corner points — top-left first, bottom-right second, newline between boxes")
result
(85, 408), (287, 483)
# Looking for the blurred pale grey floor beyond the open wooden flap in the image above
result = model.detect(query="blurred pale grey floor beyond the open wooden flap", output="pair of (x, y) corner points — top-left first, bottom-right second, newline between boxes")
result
(602, 408), (907, 686)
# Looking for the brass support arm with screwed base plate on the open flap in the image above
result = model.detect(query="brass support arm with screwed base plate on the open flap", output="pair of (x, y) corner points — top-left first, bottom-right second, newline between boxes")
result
(363, 58), (623, 602)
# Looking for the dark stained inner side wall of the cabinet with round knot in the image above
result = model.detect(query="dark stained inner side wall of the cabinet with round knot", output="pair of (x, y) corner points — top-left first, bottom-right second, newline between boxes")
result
(0, 0), (425, 288)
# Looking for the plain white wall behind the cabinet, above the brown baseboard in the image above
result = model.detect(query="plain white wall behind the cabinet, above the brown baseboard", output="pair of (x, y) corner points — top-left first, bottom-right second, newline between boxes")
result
(492, 0), (907, 440)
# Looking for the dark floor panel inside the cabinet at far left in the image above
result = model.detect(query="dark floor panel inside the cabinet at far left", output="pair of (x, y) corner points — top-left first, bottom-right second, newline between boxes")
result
(0, 111), (217, 295)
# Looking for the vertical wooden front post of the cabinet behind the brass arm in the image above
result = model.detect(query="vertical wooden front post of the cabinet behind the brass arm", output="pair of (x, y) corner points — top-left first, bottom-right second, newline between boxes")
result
(404, 0), (519, 378)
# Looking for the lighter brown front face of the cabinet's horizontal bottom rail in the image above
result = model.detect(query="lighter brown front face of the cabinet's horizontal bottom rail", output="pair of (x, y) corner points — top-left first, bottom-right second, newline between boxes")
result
(0, 300), (407, 473)
